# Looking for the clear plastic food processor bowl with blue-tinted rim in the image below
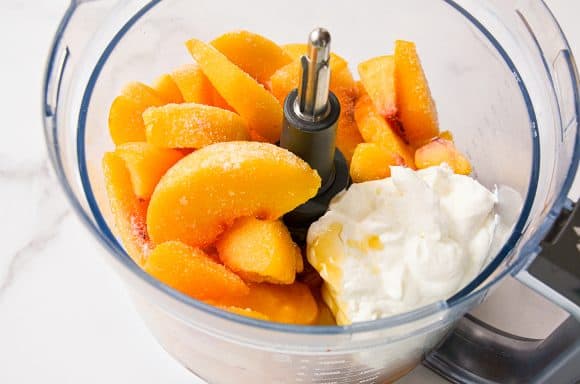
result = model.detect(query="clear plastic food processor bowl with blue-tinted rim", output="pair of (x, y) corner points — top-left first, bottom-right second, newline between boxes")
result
(43, 0), (579, 383)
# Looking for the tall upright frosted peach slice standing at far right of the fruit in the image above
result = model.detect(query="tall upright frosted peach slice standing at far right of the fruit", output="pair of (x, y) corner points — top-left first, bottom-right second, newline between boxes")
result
(395, 40), (439, 147)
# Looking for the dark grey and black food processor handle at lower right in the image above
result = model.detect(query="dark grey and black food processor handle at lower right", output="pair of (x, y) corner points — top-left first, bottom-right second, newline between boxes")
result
(424, 201), (580, 384)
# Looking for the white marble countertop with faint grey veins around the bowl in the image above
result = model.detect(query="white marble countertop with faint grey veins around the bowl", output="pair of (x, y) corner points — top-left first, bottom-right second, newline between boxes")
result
(0, 0), (580, 384)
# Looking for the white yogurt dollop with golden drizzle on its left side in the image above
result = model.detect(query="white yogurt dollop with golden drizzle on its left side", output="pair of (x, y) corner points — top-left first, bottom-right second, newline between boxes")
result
(307, 165), (498, 325)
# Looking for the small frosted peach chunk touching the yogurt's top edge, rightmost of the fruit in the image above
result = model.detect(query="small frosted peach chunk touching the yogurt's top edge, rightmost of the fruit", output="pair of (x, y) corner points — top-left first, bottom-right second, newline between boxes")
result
(415, 138), (471, 175)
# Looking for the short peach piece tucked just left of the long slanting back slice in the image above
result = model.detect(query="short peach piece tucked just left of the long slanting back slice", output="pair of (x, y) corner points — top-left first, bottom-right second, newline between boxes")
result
(171, 64), (213, 105)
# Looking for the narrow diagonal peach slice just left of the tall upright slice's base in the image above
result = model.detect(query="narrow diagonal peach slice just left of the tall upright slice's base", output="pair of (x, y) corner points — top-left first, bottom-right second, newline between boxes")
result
(354, 94), (415, 168)
